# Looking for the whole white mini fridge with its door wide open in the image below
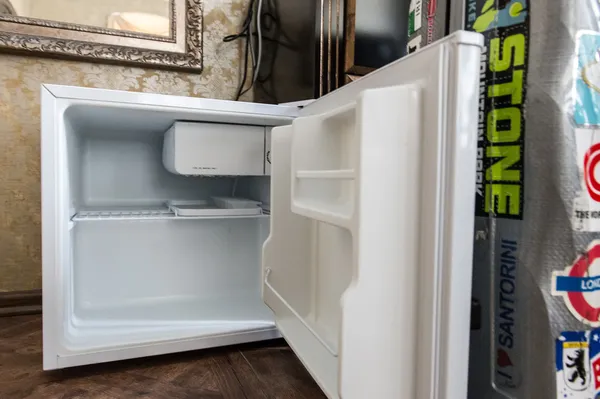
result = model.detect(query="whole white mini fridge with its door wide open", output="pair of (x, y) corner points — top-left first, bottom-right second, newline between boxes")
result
(41, 32), (482, 399)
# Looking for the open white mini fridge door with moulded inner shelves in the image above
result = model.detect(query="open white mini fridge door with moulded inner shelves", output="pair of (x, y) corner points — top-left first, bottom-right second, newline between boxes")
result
(263, 32), (481, 399)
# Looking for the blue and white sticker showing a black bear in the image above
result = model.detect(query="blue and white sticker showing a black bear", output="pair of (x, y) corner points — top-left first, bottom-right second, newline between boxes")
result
(556, 329), (600, 399)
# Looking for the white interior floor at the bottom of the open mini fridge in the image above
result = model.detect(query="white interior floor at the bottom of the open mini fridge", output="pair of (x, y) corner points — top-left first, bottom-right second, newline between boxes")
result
(64, 294), (275, 353)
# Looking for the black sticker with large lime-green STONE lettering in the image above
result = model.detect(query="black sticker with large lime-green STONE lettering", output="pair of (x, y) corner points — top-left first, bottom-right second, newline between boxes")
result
(465, 0), (530, 219)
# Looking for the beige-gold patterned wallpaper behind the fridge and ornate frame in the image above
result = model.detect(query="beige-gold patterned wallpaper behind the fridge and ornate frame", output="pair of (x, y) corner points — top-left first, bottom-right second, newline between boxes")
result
(0, 0), (251, 291)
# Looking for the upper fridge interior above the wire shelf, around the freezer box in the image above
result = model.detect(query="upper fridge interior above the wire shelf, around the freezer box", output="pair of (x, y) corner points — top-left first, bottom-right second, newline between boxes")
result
(64, 106), (269, 217)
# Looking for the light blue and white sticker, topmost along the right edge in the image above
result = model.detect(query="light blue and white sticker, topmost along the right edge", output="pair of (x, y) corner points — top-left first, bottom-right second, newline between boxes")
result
(573, 31), (600, 126)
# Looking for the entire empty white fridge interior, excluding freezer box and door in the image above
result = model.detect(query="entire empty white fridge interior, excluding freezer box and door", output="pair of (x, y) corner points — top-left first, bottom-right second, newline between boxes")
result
(62, 104), (274, 351)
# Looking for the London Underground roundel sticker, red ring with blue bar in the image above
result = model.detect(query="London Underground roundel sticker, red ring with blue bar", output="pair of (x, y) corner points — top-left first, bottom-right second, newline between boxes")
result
(552, 240), (600, 327)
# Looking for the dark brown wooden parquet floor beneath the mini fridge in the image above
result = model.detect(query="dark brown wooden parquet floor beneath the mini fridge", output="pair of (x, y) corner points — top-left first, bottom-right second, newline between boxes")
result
(0, 315), (325, 399)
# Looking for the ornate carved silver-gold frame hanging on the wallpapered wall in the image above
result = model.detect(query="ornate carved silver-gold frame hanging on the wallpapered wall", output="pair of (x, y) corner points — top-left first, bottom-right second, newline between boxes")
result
(0, 0), (203, 73)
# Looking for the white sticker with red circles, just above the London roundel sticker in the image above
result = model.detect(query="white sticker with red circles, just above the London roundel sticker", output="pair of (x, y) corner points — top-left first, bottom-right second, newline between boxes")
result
(572, 128), (600, 231)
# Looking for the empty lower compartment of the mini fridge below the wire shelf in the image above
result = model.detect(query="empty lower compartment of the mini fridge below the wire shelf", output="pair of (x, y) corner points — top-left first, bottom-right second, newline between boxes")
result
(64, 218), (274, 352)
